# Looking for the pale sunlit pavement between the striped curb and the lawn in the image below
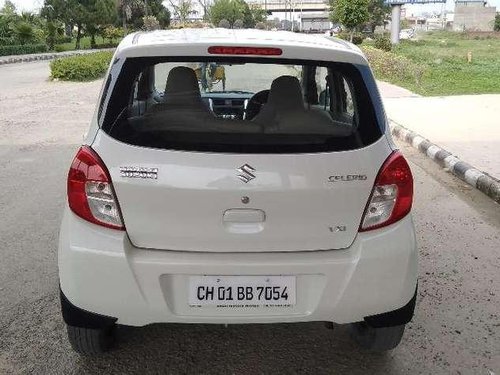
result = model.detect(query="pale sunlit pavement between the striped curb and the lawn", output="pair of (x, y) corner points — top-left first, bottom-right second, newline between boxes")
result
(380, 83), (500, 178)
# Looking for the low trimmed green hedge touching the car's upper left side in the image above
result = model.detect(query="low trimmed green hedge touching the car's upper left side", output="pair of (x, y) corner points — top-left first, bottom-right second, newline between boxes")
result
(50, 51), (113, 81)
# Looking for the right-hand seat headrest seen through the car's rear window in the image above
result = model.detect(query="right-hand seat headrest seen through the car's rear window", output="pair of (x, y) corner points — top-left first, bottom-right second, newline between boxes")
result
(267, 76), (304, 110)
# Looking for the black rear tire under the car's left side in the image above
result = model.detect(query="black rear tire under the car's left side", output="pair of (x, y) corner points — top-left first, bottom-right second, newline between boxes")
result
(66, 325), (115, 355)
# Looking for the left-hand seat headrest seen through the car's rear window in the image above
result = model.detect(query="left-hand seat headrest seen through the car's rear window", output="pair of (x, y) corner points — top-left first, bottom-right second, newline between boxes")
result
(165, 66), (201, 105)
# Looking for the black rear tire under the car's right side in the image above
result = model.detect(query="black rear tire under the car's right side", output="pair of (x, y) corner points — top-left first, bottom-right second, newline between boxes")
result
(351, 322), (405, 352)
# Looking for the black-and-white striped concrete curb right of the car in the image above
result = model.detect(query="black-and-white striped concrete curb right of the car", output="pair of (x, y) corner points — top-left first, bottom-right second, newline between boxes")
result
(390, 121), (500, 203)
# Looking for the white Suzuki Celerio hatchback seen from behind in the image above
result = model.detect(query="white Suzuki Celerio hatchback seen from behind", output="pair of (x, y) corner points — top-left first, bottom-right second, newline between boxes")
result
(59, 29), (417, 354)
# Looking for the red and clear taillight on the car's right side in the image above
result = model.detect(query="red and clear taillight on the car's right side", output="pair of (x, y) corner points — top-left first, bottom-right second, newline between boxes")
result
(359, 151), (413, 232)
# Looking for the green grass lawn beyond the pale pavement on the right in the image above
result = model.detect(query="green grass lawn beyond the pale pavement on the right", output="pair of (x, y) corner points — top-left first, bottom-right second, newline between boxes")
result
(364, 32), (500, 96)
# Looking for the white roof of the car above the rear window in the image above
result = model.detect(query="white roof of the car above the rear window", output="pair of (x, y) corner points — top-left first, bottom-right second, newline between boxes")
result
(115, 28), (368, 65)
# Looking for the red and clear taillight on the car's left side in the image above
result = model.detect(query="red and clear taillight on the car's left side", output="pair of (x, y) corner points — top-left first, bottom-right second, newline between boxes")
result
(68, 146), (125, 230)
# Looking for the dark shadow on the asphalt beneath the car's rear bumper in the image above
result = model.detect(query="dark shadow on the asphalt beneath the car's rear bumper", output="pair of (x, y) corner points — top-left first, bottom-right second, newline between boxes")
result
(73, 322), (394, 374)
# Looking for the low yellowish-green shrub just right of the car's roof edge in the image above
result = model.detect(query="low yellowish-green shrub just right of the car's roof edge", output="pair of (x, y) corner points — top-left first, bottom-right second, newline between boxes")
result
(362, 46), (426, 86)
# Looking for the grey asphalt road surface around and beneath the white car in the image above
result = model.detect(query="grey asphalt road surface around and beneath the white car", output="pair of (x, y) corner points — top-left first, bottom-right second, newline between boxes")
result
(0, 62), (500, 375)
